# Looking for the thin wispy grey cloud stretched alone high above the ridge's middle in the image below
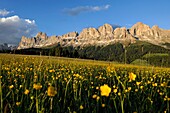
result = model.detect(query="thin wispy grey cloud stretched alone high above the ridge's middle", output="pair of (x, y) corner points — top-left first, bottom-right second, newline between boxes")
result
(63, 5), (110, 16)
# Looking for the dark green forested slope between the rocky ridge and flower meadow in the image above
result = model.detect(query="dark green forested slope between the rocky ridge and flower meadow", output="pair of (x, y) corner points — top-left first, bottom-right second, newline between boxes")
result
(1, 41), (170, 67)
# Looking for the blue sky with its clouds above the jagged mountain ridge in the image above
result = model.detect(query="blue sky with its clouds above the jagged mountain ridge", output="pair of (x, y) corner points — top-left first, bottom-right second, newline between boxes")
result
(0, 0), (170, 44)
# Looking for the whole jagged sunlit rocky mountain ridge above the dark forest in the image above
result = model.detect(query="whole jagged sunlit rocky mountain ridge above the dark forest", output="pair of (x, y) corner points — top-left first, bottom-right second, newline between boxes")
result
(18, 22), (170, 49)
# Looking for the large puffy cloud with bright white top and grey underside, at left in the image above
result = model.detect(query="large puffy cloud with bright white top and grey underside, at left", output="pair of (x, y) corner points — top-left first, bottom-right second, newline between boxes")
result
(0, 15), (37, 44)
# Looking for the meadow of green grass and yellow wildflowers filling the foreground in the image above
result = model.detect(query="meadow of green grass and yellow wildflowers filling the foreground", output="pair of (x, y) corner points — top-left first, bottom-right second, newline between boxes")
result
(0, 54), (170, 113)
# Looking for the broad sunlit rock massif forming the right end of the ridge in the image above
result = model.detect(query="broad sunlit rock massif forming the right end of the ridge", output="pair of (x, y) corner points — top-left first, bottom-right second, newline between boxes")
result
(130, 22), (170, 45)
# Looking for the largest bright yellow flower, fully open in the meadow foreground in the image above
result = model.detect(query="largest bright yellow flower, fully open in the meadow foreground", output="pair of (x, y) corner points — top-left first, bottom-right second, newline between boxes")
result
(100, 84), (111, 96)
